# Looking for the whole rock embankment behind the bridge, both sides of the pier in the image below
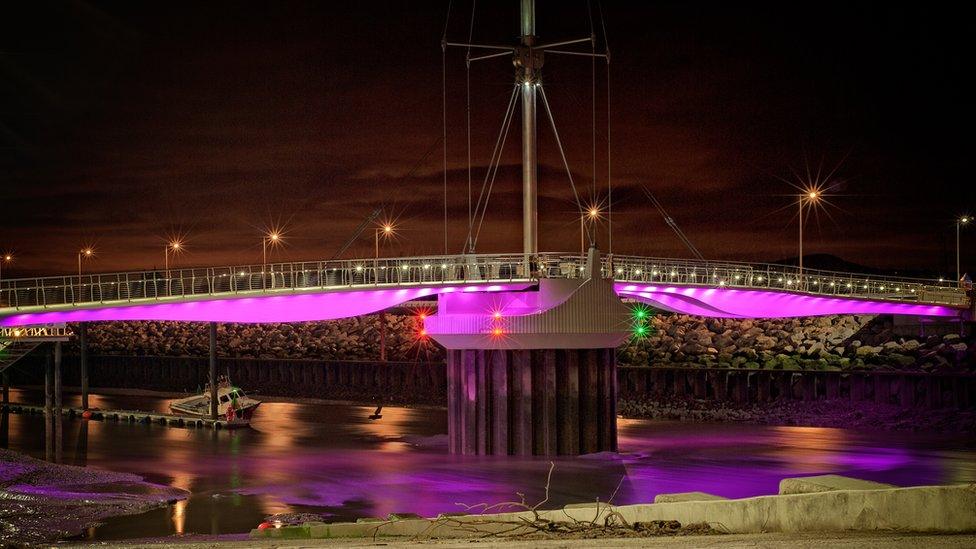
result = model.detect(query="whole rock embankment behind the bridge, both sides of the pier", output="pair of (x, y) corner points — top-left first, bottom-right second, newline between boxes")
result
(65, 314), (976, 371)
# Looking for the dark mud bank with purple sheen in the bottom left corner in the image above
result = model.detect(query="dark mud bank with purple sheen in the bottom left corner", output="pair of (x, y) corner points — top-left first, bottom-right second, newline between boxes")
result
(0, 449), (188, 547)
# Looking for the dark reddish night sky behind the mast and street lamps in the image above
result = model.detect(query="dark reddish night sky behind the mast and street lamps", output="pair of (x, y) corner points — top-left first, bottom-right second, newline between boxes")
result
(0, 0), (976, 277)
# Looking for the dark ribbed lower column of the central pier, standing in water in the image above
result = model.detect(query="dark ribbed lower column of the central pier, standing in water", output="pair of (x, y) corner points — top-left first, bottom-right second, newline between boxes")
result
(447, 348), (617, 456)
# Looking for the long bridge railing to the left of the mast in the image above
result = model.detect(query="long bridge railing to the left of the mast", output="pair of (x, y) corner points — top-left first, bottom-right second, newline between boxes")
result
(0, 255), (529, 310)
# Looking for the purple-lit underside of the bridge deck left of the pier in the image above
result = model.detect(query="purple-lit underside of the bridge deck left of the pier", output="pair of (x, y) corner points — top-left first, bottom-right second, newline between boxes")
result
(0, 283), (528, 327)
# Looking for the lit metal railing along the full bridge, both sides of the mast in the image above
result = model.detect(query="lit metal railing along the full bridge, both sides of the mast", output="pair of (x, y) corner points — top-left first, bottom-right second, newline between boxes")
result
(0, 253), (968, 311)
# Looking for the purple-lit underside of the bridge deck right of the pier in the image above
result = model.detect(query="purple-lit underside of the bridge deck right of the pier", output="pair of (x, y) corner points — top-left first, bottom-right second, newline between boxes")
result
(614, 283), (961, 318)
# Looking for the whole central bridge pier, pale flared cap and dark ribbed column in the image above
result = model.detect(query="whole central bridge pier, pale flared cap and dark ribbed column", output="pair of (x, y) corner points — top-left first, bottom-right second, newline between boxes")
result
(425, 248), (630, 456)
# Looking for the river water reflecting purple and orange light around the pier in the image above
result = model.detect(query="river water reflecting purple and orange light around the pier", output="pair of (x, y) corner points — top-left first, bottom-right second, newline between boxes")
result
(0, 390), (976, 540)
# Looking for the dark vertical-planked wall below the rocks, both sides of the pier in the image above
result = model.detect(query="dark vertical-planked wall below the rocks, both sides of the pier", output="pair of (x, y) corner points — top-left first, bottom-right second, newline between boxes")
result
(11, 353), (976, 409)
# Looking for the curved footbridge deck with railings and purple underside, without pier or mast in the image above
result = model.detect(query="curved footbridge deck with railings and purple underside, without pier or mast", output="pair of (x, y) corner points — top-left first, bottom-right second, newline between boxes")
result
(0, 254), (970, 327)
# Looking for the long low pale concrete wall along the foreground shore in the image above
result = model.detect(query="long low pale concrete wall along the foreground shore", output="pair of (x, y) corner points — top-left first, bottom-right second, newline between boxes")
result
(251, 479), (976, 539)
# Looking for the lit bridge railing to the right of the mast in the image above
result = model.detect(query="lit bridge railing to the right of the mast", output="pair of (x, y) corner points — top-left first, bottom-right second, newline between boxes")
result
(604, 256), (968, 306)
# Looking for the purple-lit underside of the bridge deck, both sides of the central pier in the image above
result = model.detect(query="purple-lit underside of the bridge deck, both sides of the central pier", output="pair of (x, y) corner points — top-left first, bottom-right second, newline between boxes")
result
(0, 283), (961, 327)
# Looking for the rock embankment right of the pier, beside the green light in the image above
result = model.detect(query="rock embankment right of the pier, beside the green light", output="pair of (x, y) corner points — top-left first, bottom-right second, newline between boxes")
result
(620, 315), (976, 371)
